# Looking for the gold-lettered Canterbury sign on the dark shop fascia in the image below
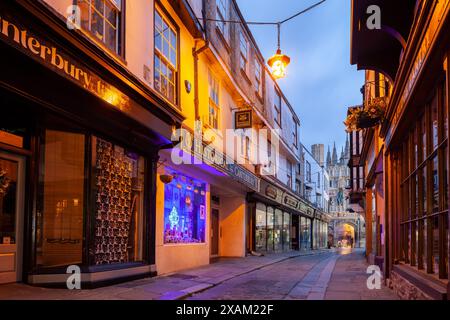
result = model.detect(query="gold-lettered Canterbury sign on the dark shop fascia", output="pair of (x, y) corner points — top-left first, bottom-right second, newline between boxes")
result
(0, 8), (131, 111)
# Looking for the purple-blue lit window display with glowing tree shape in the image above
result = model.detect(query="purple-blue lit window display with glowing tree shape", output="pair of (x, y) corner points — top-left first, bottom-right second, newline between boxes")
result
(164, 172), (206, 243)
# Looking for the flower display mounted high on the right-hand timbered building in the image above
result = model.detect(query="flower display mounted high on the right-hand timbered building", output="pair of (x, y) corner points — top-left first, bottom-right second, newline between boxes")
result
(344, 97), (387, 132)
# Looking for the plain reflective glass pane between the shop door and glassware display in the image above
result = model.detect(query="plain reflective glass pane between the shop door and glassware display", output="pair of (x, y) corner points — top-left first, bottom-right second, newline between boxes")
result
(36, 130), (85, 267)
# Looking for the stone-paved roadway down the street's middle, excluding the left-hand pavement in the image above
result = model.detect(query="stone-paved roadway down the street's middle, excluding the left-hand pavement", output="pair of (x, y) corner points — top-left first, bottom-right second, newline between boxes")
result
(188, 250), (397, 300)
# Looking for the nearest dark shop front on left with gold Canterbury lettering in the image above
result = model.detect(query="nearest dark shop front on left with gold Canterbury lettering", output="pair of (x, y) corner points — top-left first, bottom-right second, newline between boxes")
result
(0, 3), (182, 287)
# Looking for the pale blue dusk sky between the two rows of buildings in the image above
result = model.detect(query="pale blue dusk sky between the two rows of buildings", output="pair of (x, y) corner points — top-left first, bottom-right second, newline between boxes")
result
(237, 0), (364, 152)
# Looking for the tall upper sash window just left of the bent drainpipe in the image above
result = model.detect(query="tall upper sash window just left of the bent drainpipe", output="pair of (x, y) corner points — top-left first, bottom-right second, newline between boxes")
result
(155, 10), (178, 104)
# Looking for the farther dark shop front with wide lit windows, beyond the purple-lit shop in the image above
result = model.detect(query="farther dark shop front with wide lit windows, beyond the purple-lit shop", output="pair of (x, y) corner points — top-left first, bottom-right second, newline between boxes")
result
(248, 179), (314, 252)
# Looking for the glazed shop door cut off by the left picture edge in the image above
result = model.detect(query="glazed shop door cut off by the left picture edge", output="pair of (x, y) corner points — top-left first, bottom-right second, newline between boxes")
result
(0, 151), (25, 283)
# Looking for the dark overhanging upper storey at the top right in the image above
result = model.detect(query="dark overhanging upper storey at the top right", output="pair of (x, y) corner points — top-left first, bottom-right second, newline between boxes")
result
(351, 0), (419, 80)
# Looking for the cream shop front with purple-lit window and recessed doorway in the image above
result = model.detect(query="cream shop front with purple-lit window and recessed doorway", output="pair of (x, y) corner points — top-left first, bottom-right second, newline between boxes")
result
(156, 137), (260, 274)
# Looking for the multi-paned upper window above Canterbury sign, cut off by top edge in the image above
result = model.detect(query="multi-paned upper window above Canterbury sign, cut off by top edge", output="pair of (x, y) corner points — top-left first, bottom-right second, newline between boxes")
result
(78, 0), (122, 55)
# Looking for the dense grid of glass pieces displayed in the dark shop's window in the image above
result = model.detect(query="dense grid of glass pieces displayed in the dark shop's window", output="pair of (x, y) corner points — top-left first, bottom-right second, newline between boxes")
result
(95, 138), (138, 265)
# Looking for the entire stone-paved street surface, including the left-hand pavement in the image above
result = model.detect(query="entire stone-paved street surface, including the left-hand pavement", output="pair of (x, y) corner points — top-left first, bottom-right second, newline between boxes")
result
(0, 250), (396, 300)
